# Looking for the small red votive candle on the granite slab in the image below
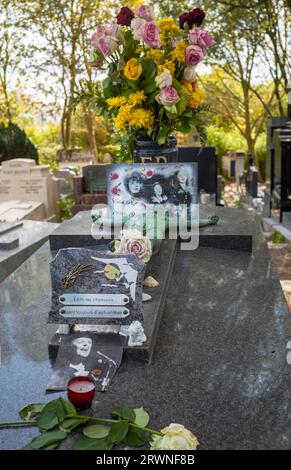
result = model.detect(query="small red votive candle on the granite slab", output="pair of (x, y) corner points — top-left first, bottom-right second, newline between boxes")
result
(67, 375), (95, 410)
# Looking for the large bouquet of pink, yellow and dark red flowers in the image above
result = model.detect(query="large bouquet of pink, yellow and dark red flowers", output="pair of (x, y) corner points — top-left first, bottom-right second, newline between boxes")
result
(91, 5), (214, 155)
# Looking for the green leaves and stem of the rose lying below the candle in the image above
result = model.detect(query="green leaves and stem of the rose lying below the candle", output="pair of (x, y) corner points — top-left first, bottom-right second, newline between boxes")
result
(1, 398), (161, 450)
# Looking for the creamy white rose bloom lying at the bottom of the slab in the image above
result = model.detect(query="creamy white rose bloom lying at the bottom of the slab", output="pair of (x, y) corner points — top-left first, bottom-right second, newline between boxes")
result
(150, 423), (199, 450)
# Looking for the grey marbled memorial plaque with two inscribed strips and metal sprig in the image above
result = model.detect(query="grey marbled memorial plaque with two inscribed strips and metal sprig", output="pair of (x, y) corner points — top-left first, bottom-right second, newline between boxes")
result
(49, 248), (145, 325)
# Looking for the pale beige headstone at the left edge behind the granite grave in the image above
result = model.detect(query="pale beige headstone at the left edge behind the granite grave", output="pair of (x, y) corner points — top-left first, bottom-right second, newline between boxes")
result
(0, 158), (59, 221)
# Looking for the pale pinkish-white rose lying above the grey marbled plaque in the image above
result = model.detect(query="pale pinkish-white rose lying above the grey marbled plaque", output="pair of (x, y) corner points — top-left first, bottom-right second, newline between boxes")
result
(115, 229), (152, 263)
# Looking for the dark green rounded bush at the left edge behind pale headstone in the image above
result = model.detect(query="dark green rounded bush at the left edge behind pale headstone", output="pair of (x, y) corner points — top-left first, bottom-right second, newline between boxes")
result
(0, 122), (38, 162)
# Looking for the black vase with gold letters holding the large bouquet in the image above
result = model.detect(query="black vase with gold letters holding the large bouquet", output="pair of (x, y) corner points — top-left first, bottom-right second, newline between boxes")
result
(133, 137), (178, 163)
